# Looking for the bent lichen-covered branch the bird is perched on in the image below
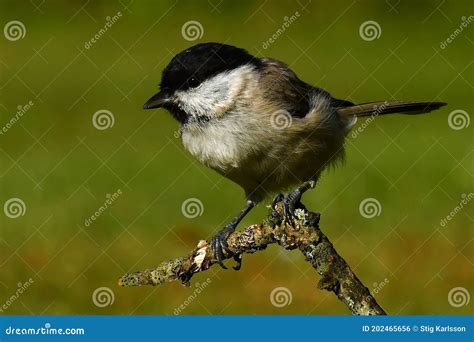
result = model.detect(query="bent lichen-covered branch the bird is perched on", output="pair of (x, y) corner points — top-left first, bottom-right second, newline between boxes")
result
(119, 203), (386, 315)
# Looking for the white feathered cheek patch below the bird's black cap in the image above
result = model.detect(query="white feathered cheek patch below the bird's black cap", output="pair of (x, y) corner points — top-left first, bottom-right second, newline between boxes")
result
(175, 65), (254, 117)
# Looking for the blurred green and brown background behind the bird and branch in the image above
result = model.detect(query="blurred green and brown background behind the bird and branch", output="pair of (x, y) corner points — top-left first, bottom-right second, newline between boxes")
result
(0, 0), (474, 315)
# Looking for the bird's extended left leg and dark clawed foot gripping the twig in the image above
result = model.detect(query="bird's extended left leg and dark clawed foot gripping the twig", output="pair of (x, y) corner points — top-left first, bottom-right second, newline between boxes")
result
(211, 200), (255, 271)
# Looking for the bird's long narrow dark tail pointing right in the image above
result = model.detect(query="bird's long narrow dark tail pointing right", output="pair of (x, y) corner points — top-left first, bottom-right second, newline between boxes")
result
(337, 101), (446, 117)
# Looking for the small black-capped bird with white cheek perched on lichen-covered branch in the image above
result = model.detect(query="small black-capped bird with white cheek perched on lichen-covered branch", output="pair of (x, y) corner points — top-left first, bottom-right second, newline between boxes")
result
(144, 43), (446, 269)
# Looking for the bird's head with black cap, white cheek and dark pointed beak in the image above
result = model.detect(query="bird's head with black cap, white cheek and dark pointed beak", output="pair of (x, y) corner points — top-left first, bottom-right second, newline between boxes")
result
(144, 43), (261, 124)
